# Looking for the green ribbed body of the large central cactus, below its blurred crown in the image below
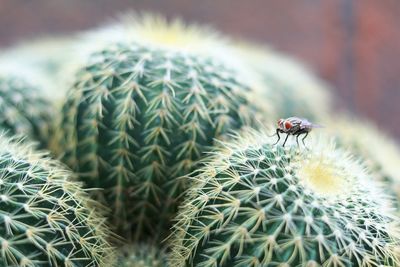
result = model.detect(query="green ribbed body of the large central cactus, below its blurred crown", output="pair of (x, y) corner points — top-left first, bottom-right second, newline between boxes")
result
(59, 43), (257, 243)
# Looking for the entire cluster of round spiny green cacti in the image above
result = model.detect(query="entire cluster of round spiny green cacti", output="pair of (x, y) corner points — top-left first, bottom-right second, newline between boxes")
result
(0, 11), (400, 267)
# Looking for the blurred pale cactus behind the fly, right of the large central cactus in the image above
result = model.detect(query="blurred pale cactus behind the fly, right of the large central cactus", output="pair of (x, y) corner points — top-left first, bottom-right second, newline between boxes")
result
(233, 41), (332, 123)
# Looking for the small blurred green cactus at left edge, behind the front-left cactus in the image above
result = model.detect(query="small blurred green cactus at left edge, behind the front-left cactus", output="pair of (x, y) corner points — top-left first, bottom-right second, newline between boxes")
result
(0, 75), (54, 148)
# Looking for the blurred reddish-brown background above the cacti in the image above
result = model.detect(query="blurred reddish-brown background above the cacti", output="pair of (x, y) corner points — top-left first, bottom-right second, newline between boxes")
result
(0, 0), (400, 140)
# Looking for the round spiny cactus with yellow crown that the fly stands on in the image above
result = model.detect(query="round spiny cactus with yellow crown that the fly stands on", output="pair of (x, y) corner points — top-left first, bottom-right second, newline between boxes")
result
(170, 133), (400, 267)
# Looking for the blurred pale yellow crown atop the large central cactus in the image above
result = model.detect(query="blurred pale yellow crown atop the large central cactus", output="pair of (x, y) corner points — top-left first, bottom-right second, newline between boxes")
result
(80, 13), (229, 65)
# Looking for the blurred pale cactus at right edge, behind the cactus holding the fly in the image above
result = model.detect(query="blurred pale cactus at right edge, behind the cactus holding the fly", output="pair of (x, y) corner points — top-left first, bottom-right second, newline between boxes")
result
(326, 116), (400, 210)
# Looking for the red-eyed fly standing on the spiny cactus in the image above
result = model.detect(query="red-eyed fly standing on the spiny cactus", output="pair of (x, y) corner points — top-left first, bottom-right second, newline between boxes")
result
(274, 117), (322, 146)
